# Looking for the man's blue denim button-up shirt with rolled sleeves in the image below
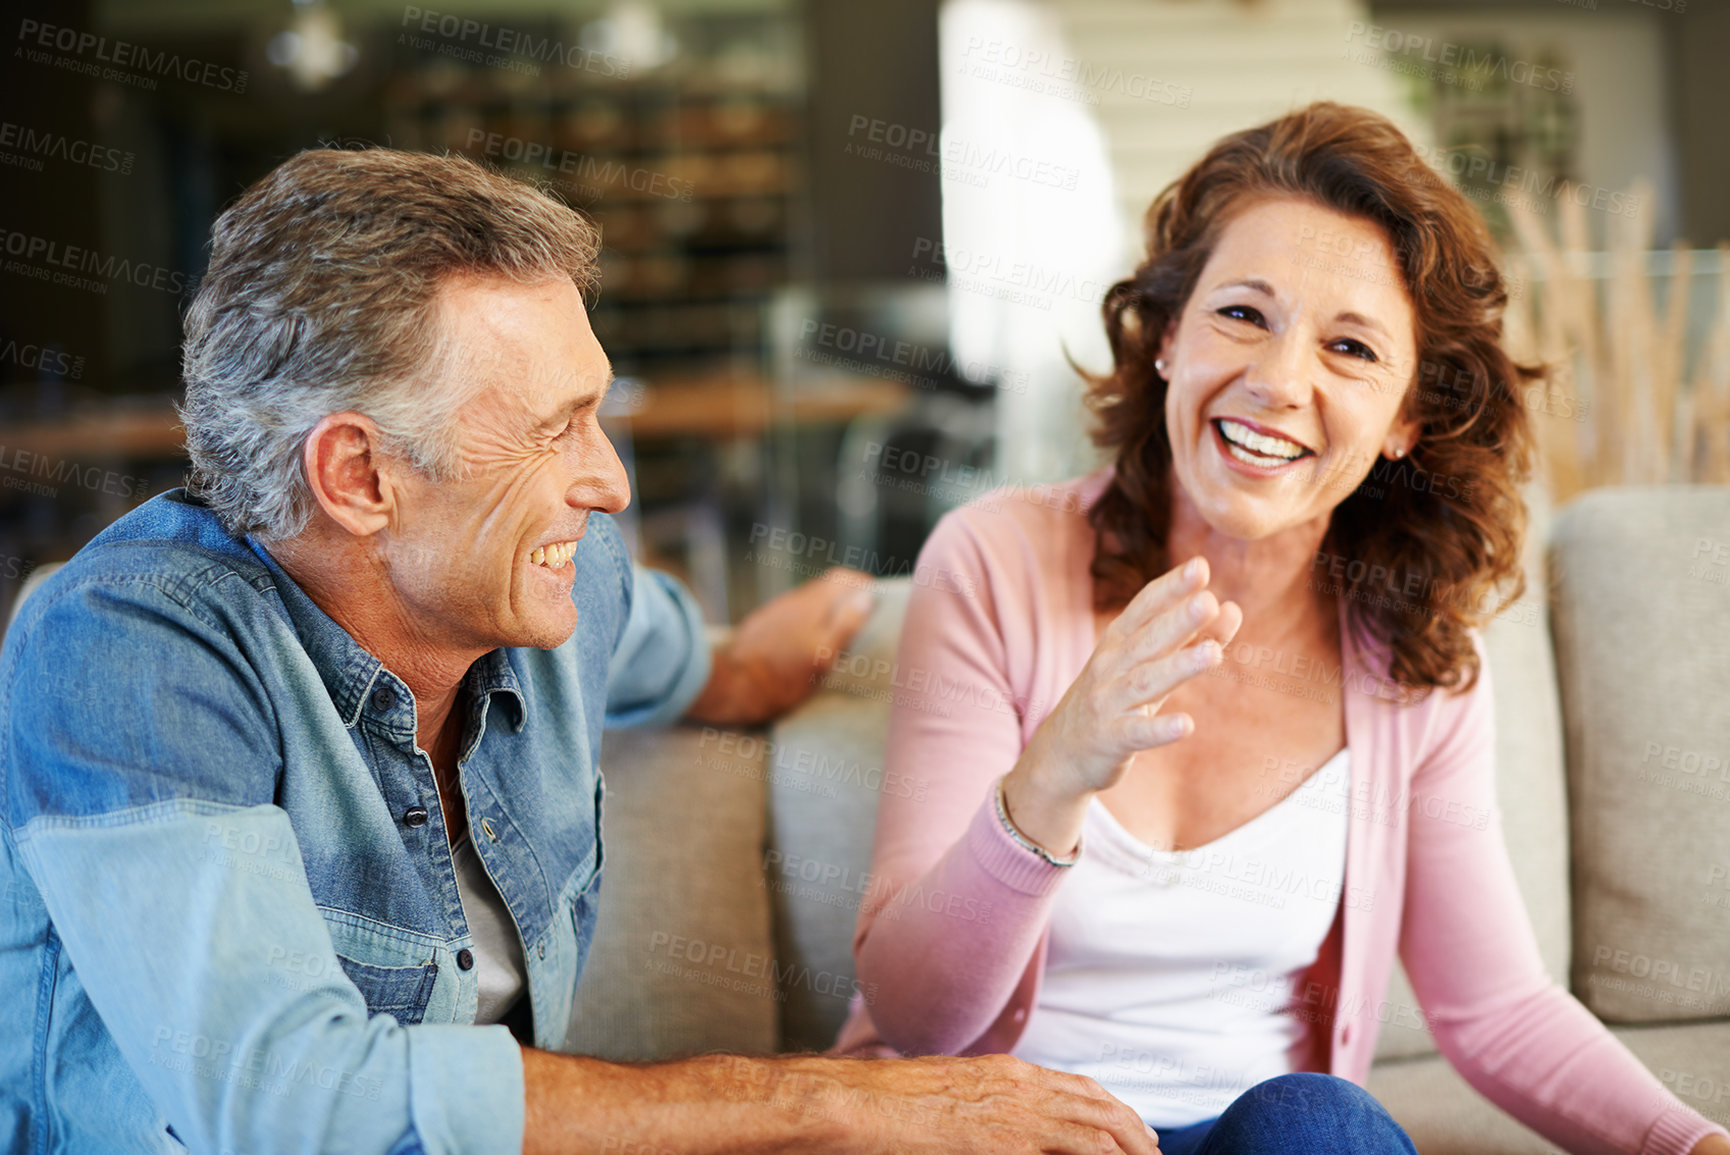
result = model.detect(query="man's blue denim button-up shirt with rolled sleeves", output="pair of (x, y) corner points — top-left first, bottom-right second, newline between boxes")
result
(0, 489), (709, 1155)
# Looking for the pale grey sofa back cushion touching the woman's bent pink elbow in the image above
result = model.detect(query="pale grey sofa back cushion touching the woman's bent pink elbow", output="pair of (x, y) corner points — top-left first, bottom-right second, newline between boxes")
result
(763, 579), (926, 1050)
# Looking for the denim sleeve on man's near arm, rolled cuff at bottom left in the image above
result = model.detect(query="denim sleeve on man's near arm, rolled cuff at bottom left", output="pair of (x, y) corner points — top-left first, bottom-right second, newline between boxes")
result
(5, 584), (524, 1155)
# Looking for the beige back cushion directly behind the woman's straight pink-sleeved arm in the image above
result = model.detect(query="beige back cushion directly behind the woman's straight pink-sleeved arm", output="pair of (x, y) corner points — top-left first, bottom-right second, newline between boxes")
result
(1375, 484), (1569, 1058)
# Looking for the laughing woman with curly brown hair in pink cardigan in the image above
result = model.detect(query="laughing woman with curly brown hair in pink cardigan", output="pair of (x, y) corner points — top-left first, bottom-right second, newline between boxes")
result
(837, 104), (1730, 1155)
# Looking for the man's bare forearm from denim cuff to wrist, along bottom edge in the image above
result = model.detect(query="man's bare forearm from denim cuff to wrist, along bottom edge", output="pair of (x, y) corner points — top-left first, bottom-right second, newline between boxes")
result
(522, 1048), (868, 1155)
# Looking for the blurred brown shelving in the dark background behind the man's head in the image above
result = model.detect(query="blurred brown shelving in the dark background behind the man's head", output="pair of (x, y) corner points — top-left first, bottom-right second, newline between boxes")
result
(384, 24), (806, 377)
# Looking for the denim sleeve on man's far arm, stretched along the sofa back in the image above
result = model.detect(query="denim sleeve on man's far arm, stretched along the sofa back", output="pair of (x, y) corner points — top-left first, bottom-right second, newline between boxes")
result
(607, 565), (711, 730)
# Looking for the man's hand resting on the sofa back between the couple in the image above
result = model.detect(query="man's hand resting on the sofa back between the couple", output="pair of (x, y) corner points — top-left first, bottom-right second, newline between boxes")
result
(685, 567), (875, 726)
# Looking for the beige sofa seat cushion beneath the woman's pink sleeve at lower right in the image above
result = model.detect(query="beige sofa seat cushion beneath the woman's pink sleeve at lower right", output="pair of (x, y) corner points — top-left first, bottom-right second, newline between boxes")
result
(1368, 1022), (1730, 1155)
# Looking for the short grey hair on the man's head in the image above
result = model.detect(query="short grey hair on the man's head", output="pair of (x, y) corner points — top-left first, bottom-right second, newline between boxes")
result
(178, 149), (600, 539)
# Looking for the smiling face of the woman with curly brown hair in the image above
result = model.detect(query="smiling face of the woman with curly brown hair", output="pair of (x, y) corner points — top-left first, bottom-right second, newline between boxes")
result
(1159, 197), (1417, 539)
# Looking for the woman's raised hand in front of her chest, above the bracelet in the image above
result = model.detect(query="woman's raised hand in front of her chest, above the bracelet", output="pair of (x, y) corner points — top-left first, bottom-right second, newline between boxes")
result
(1003, 557), (1244, 854)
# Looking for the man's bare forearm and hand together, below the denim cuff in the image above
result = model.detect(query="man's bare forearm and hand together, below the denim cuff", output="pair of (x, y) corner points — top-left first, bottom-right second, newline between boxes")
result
(522, 1050), (1159, 1155)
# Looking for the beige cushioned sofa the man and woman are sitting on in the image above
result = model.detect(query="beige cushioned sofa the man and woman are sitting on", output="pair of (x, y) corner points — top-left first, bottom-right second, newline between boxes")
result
(569, 486), (1730, 1155)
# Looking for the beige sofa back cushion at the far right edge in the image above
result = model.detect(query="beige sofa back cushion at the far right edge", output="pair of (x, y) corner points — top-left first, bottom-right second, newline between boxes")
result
(1550, 486), (1730, 1022)
